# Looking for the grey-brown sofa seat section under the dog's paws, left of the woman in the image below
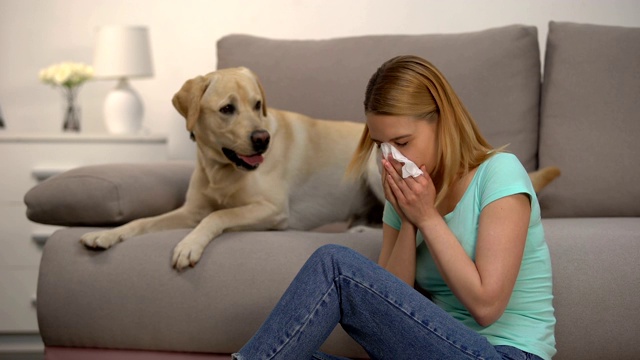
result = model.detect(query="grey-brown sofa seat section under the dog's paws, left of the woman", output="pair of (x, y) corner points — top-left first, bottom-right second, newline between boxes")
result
(37, 228), (382, 358)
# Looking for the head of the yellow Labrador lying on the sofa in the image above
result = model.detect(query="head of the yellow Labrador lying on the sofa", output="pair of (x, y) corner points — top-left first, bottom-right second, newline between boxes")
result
(172, 67), (271, 170)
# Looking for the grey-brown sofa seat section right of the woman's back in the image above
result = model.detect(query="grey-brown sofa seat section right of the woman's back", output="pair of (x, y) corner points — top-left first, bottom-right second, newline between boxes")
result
(543, 218), (640, 360)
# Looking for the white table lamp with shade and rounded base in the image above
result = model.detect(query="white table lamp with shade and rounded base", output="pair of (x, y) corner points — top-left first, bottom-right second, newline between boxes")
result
(93, 25), (153, 134)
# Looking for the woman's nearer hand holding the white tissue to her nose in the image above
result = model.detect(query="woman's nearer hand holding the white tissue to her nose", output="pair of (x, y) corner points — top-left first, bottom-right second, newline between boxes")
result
(382, 159), (439, 227)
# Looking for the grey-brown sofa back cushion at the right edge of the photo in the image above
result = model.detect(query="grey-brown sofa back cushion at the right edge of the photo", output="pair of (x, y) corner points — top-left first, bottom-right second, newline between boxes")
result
(540, 22), (640, 217)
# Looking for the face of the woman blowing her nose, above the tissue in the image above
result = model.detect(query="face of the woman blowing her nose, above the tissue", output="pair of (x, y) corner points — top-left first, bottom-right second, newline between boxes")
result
(367, 114), (438, 175)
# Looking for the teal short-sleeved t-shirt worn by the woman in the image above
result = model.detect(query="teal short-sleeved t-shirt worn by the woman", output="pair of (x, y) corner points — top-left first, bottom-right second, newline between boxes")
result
(383, 153), (556, 359)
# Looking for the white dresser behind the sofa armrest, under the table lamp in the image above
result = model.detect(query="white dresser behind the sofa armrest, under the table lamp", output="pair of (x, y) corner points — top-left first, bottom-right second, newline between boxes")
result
(0, 131), (168, 336)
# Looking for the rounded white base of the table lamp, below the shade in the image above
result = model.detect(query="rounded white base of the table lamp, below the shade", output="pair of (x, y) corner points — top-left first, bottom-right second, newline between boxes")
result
(103, 78), (144, 134)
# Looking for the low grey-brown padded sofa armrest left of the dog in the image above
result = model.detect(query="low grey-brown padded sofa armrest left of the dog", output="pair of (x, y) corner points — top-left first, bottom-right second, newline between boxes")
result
(24, 162), (194, 226)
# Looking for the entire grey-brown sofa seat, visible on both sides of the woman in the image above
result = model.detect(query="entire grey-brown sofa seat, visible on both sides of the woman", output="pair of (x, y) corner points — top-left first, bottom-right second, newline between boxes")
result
(38, 218), (640, 359)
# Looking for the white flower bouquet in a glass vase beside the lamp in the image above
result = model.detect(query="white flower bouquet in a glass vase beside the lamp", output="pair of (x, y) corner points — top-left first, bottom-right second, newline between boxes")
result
(39, 62), (93, 132)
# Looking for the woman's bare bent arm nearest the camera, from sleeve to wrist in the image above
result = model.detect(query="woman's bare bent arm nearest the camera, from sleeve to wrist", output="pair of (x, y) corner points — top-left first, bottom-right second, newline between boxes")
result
(419, 194), (531, 326)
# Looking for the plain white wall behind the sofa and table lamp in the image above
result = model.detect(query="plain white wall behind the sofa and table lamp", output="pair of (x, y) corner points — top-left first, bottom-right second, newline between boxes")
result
(0, 0), (640, 158)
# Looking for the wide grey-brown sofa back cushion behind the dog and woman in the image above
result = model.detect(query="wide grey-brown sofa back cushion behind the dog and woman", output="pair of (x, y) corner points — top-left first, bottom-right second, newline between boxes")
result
(217, 25), (541, 170)
